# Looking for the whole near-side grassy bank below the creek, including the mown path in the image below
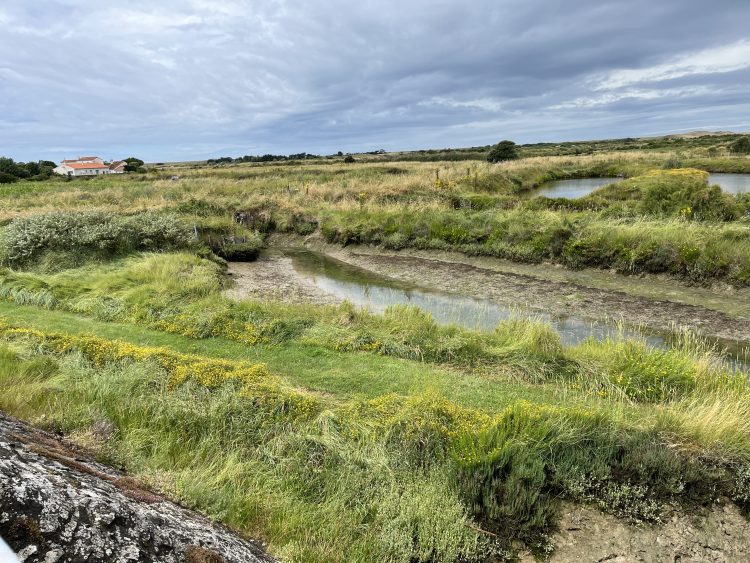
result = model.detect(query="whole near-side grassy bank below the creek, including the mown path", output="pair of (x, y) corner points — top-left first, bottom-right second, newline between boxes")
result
(0, 248), (750, 561)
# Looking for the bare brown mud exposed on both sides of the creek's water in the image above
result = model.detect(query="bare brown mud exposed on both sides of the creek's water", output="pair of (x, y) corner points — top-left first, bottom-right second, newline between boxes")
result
(225, 237), (750, 351)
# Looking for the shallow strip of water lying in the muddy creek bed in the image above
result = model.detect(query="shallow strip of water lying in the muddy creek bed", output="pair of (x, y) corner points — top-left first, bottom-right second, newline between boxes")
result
(287, 251), (666, 346)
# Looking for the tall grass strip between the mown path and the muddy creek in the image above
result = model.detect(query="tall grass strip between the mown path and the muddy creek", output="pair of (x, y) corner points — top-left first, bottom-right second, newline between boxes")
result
(0, 253), (742, 402)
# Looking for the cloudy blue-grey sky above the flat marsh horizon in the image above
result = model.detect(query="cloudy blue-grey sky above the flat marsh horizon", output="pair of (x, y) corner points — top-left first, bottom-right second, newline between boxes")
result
(0, 0), (750, 161)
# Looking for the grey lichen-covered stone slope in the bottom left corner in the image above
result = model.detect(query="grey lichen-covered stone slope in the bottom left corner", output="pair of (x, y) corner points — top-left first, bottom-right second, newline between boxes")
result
(0, 413), (273, 563)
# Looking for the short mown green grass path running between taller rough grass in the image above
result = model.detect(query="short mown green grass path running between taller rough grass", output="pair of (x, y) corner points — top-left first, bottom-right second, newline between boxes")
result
(0, 302), (586, 411)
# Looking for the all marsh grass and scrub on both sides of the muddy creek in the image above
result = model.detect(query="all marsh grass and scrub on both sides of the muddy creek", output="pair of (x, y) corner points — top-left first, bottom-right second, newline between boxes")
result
(0, 138), (750, 561)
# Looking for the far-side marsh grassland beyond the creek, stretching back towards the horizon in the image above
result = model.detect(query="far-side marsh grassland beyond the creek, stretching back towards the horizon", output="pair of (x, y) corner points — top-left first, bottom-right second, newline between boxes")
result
(2, 151), (750, 286)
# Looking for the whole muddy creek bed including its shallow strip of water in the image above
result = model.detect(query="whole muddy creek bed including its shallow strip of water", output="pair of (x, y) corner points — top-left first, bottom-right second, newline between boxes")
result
(227, 240), (750, 357)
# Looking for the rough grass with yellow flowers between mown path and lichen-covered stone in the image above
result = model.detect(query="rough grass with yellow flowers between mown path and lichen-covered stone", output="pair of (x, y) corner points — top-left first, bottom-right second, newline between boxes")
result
(0, 310), (750, 561)
